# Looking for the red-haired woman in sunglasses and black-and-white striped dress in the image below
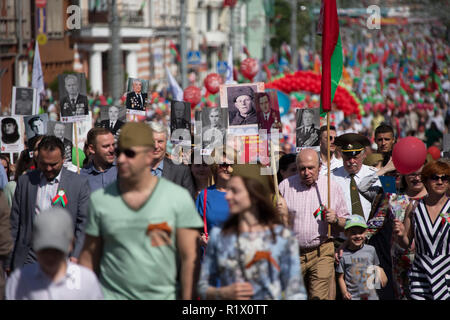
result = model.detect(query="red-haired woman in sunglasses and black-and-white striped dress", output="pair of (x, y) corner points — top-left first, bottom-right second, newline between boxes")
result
(394, 160), (450, 300)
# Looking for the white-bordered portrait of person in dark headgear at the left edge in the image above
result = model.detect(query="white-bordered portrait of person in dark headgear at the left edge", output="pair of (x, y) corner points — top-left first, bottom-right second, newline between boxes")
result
(0, 116), (24, 152)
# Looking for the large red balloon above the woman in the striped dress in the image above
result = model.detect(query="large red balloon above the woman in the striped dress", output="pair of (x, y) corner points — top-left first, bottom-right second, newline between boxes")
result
(392, 137), (427, 174)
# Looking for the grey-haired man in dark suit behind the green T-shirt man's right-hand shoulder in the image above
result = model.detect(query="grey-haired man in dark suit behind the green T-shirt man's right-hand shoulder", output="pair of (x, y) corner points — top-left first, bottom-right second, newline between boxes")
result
(150, 122), (195, 198)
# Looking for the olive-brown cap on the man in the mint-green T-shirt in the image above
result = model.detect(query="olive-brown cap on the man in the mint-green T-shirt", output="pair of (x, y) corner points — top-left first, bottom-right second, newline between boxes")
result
(118, 122), (155, 150)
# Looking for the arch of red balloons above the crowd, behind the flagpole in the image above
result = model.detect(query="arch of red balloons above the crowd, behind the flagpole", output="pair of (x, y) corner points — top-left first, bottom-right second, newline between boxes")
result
(265, 71), (363, 118)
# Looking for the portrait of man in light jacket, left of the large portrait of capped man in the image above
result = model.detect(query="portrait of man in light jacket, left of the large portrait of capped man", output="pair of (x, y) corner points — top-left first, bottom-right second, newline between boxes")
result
(202, 107), (228, 149)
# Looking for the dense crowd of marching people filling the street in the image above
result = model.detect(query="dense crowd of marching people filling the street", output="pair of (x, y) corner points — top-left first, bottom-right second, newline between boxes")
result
(0, 19), (450, 300)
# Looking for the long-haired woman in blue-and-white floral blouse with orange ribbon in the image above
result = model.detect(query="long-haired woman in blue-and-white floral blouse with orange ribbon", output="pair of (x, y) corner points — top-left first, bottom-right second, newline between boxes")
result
(198, 172), (306, 300)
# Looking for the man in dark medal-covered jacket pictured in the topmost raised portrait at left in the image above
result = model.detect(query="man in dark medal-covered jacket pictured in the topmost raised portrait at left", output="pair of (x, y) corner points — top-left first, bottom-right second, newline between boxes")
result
(61, 74), (89, 117)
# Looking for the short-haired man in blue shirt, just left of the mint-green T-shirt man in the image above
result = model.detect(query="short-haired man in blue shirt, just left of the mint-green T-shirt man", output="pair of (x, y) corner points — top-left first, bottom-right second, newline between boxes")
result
(80, 128), (117, 192)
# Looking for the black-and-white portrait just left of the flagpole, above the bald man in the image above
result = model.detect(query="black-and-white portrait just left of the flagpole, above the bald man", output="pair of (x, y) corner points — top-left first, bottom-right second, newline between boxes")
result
(295, 108), (320, 148)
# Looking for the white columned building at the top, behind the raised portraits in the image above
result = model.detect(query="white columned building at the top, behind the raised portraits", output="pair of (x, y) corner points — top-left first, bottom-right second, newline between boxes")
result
(72, 0), (262, 93)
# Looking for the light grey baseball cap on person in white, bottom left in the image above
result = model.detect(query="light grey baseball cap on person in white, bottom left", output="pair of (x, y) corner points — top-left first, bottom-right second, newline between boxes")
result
(33, 208), (74, 255)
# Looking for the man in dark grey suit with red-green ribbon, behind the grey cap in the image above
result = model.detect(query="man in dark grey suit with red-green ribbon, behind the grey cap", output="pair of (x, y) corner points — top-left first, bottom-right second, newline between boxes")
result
(7, 136), (90, 271)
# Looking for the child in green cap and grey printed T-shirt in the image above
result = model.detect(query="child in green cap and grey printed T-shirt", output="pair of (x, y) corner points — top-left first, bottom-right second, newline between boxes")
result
(336, 215), (387, 300)
